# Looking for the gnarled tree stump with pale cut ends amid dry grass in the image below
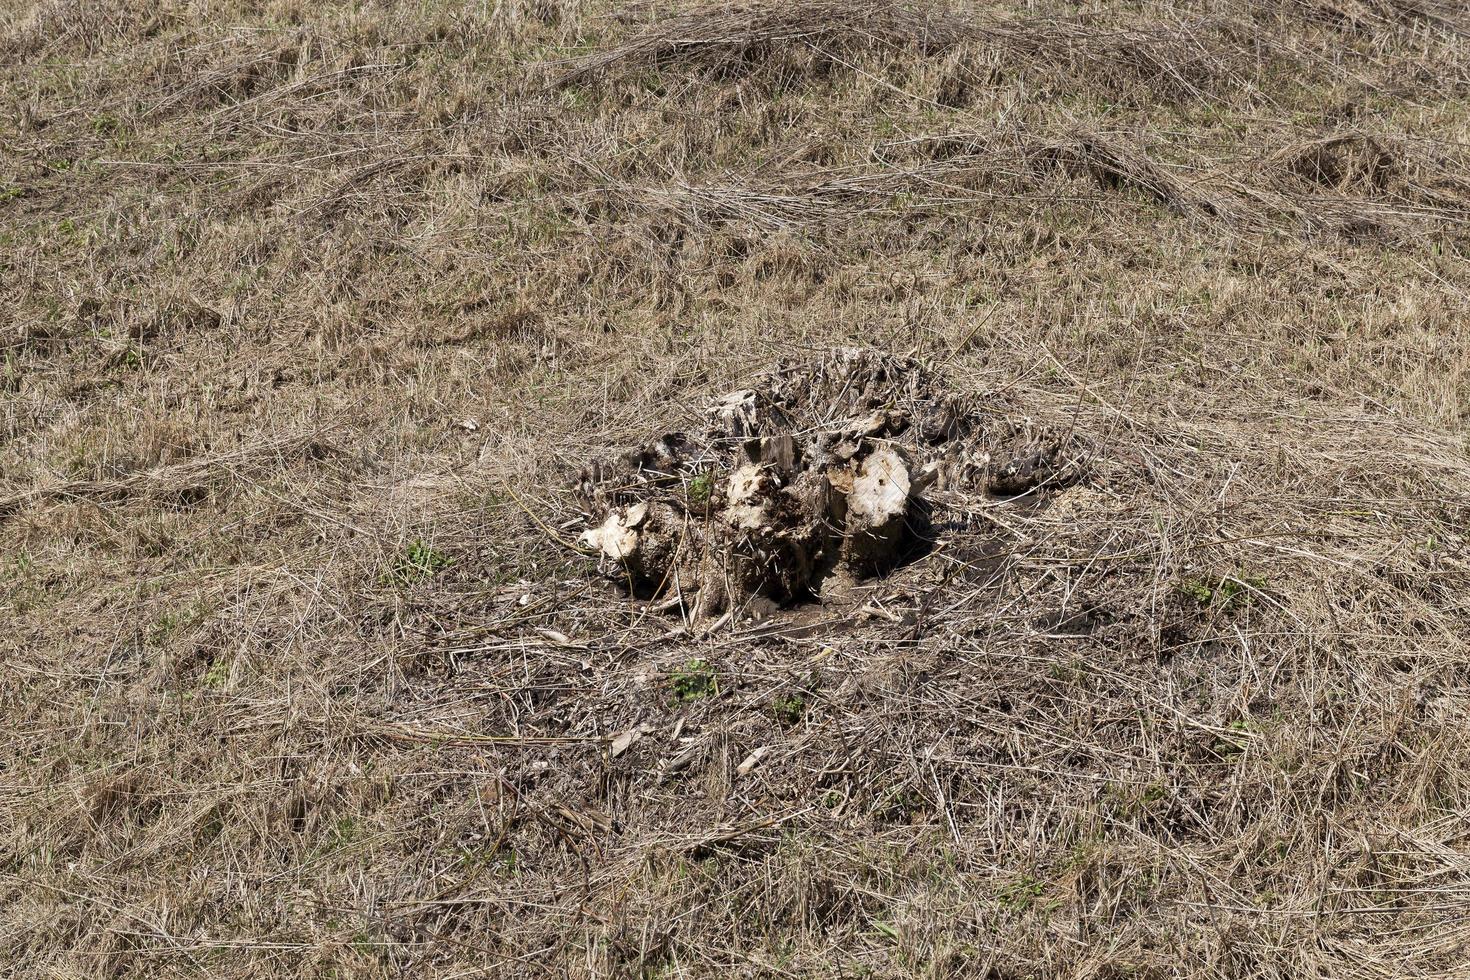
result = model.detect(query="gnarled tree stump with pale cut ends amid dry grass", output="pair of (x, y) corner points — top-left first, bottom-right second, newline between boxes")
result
(581, 348), (1085, 623)
